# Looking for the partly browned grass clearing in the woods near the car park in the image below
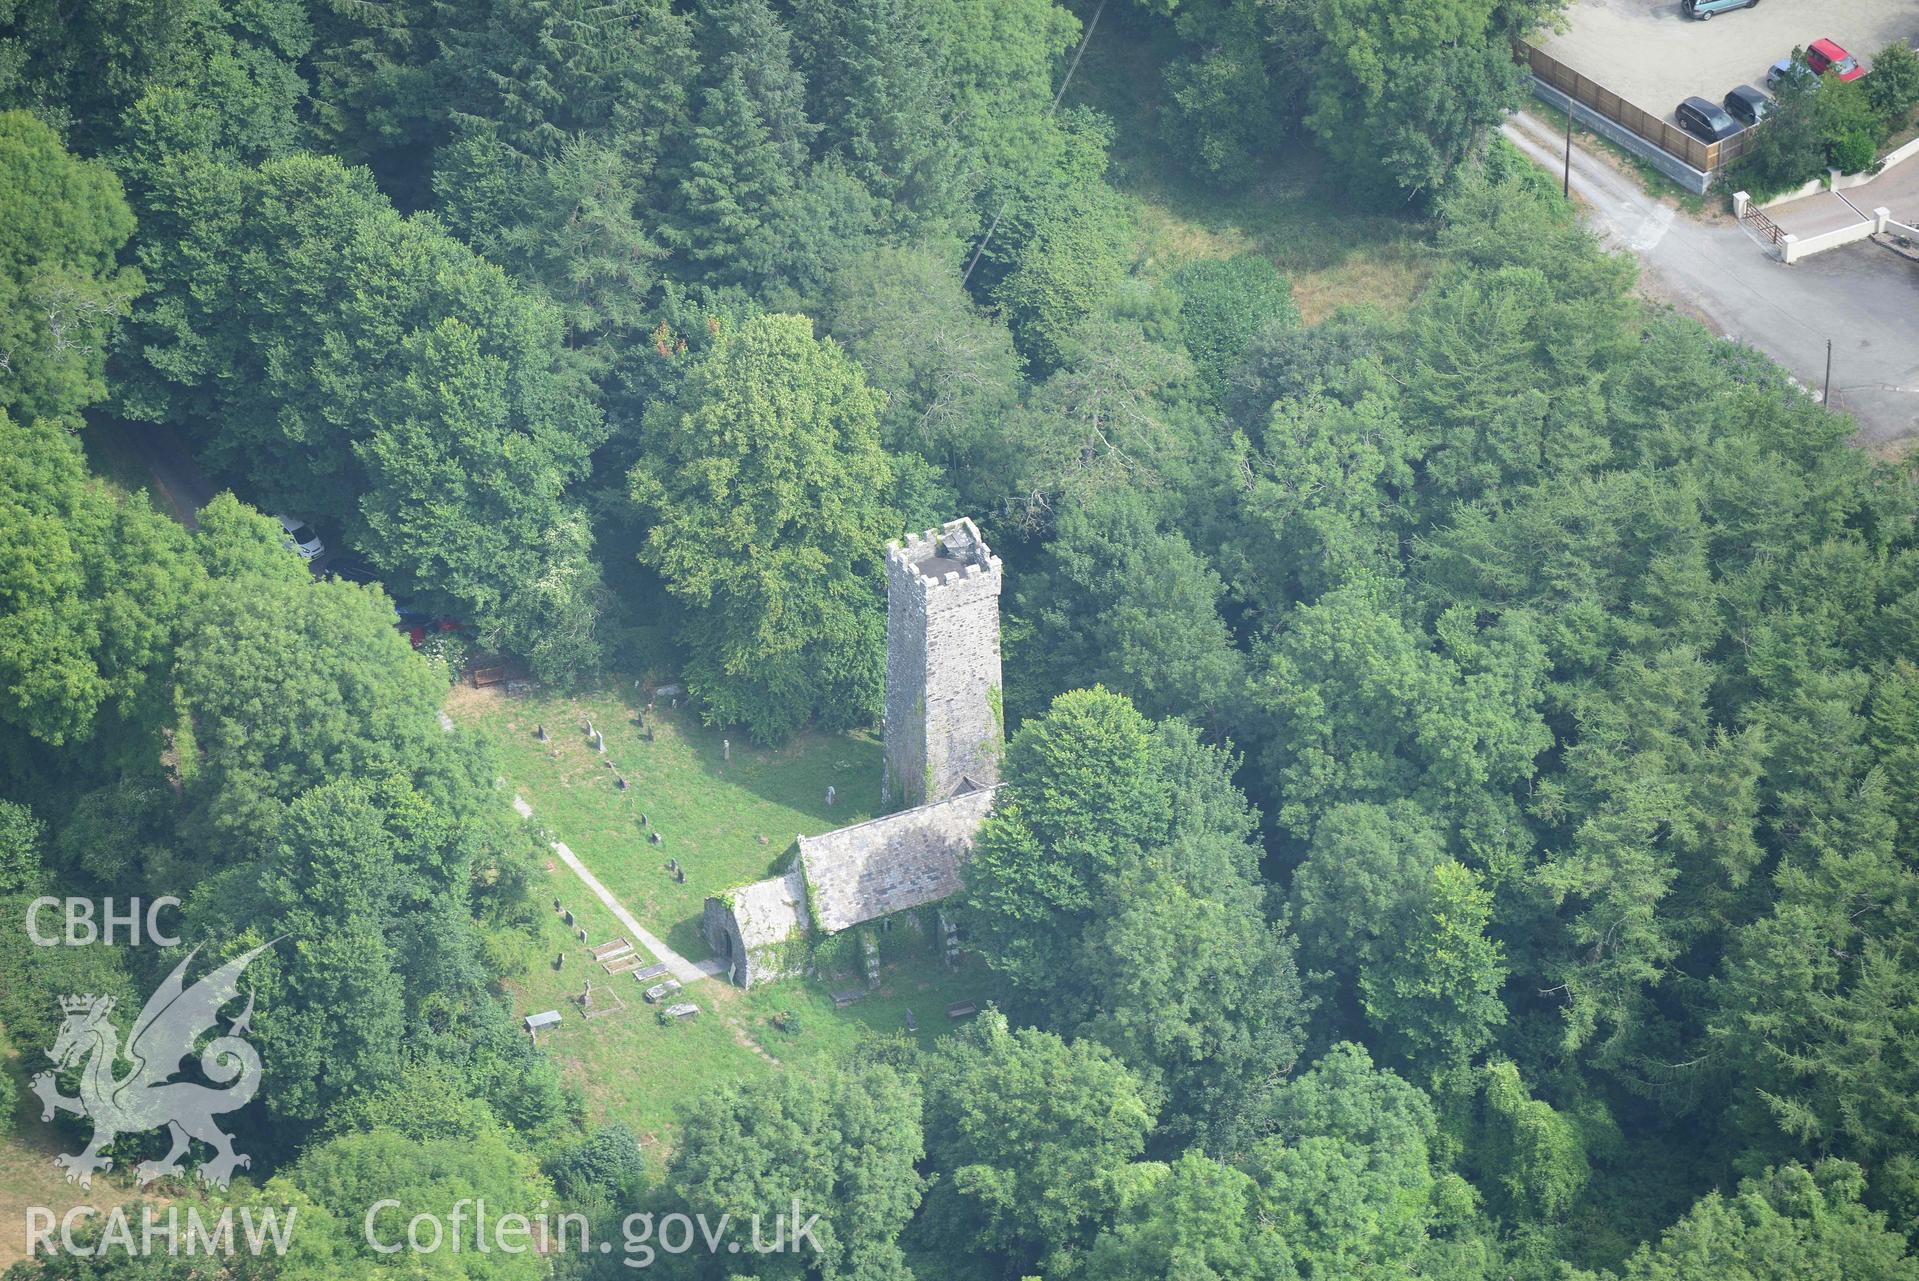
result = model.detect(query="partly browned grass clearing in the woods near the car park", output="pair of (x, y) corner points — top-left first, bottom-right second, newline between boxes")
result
(1069, 12), (1432, 324)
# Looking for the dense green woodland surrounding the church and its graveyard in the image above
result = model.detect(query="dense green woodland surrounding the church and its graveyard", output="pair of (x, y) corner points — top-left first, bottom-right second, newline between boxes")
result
(0, 0), (1919, 1281)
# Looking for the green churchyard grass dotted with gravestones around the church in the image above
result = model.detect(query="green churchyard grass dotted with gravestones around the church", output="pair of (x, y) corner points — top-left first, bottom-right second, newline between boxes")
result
(458, 685), (996, 1172)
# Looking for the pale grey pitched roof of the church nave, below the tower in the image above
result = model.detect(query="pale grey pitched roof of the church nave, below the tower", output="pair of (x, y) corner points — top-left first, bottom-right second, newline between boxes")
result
(798, 788), (998, 934)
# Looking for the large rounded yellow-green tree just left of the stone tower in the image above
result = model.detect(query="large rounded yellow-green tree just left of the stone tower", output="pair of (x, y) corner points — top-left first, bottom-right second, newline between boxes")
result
(631, 308), (894, 740)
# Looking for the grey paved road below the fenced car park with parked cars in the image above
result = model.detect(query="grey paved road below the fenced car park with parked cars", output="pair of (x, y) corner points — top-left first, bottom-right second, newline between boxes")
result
(1503, 111), (1919, 447)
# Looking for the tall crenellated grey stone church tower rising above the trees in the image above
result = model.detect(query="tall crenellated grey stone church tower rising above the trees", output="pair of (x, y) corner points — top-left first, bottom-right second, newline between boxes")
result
(881, 518), (1006, 805)
